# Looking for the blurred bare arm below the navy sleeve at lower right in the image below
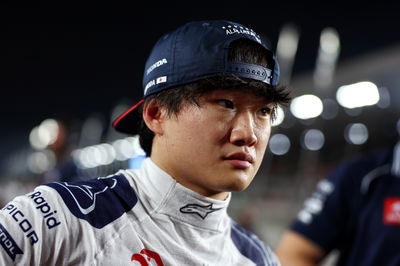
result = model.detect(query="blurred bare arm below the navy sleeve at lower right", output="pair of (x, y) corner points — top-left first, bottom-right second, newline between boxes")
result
(275, 231), (325, 266)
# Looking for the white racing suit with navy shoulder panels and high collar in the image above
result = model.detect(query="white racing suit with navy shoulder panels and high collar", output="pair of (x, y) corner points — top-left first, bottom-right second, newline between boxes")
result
(0, 159), (279, 266)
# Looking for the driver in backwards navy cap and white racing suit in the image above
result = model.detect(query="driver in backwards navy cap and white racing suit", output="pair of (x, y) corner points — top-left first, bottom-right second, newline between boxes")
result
(0, 21), (289, 265)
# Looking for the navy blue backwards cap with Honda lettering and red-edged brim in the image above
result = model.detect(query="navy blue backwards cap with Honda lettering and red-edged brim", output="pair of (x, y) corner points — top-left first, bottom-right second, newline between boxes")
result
(112, 20), (279, 134)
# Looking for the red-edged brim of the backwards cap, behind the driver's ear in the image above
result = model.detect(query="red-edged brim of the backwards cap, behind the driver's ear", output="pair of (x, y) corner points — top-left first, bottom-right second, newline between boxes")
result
(112, 99), (144, 135)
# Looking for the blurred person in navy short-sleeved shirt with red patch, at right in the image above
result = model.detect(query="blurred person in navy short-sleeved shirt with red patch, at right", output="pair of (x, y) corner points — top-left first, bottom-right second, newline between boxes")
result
(276, 142), (400, 266)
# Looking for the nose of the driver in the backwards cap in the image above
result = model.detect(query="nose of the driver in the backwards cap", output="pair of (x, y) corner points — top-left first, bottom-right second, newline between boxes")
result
(230, 112), (257, 146)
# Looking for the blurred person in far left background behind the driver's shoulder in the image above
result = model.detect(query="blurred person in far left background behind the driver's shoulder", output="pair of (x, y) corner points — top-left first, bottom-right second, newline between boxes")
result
(0, 117), (84, 211)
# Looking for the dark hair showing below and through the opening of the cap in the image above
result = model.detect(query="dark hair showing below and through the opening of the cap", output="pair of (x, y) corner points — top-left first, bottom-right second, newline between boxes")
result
(139, 39), (290, 156)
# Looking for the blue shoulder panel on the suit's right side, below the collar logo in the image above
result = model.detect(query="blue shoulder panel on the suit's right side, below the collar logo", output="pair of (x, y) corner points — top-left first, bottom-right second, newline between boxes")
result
(231, 221), (278, 266)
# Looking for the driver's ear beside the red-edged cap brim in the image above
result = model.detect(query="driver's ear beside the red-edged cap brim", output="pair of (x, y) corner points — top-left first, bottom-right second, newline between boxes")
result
(142, 101), (166, 135)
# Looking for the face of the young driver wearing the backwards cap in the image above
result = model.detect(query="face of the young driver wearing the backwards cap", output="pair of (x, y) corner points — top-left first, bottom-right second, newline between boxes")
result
(151, 90), (273, 199)
